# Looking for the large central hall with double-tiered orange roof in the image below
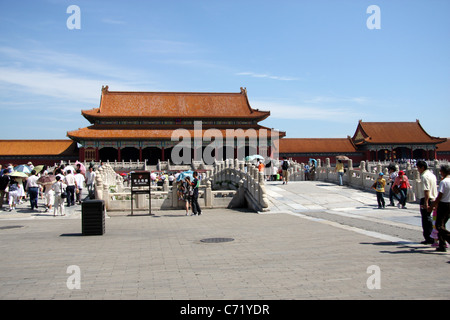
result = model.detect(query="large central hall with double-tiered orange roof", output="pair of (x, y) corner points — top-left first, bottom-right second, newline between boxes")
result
(67, 86), (285, 164)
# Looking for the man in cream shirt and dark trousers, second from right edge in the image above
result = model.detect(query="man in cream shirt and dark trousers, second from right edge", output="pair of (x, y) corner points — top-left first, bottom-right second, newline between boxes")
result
(417, 160), (437, 244)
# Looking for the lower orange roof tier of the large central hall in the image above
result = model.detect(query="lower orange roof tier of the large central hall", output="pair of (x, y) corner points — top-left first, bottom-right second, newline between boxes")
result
(67, 125), (285, 141)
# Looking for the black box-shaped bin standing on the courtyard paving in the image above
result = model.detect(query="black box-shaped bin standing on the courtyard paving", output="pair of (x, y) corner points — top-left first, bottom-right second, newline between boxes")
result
(81, 200), (105, 236)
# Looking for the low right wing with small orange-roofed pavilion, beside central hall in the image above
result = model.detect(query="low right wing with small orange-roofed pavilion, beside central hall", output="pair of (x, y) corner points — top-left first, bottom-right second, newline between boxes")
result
(280, 120), (450, 162)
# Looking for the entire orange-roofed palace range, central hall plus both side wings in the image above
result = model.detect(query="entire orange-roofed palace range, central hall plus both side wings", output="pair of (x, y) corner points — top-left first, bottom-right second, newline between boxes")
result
(0, 86), (450, 165)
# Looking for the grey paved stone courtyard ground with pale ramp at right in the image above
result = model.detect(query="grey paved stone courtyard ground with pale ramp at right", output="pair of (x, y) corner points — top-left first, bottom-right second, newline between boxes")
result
(0, 182), (450, 300)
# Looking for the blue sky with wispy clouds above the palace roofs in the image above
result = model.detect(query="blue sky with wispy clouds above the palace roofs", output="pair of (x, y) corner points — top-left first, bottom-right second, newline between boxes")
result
(0, 0), (450, 139)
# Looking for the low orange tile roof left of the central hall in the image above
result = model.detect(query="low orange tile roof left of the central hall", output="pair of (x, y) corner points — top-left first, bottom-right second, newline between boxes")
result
(0, 140), (77, 156)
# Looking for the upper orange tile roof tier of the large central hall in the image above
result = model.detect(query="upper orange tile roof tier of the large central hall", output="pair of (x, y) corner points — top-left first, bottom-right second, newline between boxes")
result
(82, 86), (270, 122)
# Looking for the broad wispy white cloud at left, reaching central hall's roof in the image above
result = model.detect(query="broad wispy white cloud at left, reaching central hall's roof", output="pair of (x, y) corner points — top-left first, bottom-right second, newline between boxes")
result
(0, 47), (157, 105)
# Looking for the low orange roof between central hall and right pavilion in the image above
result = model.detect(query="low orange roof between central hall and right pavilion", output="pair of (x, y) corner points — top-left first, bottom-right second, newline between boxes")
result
(279, 138), (357, 153)
